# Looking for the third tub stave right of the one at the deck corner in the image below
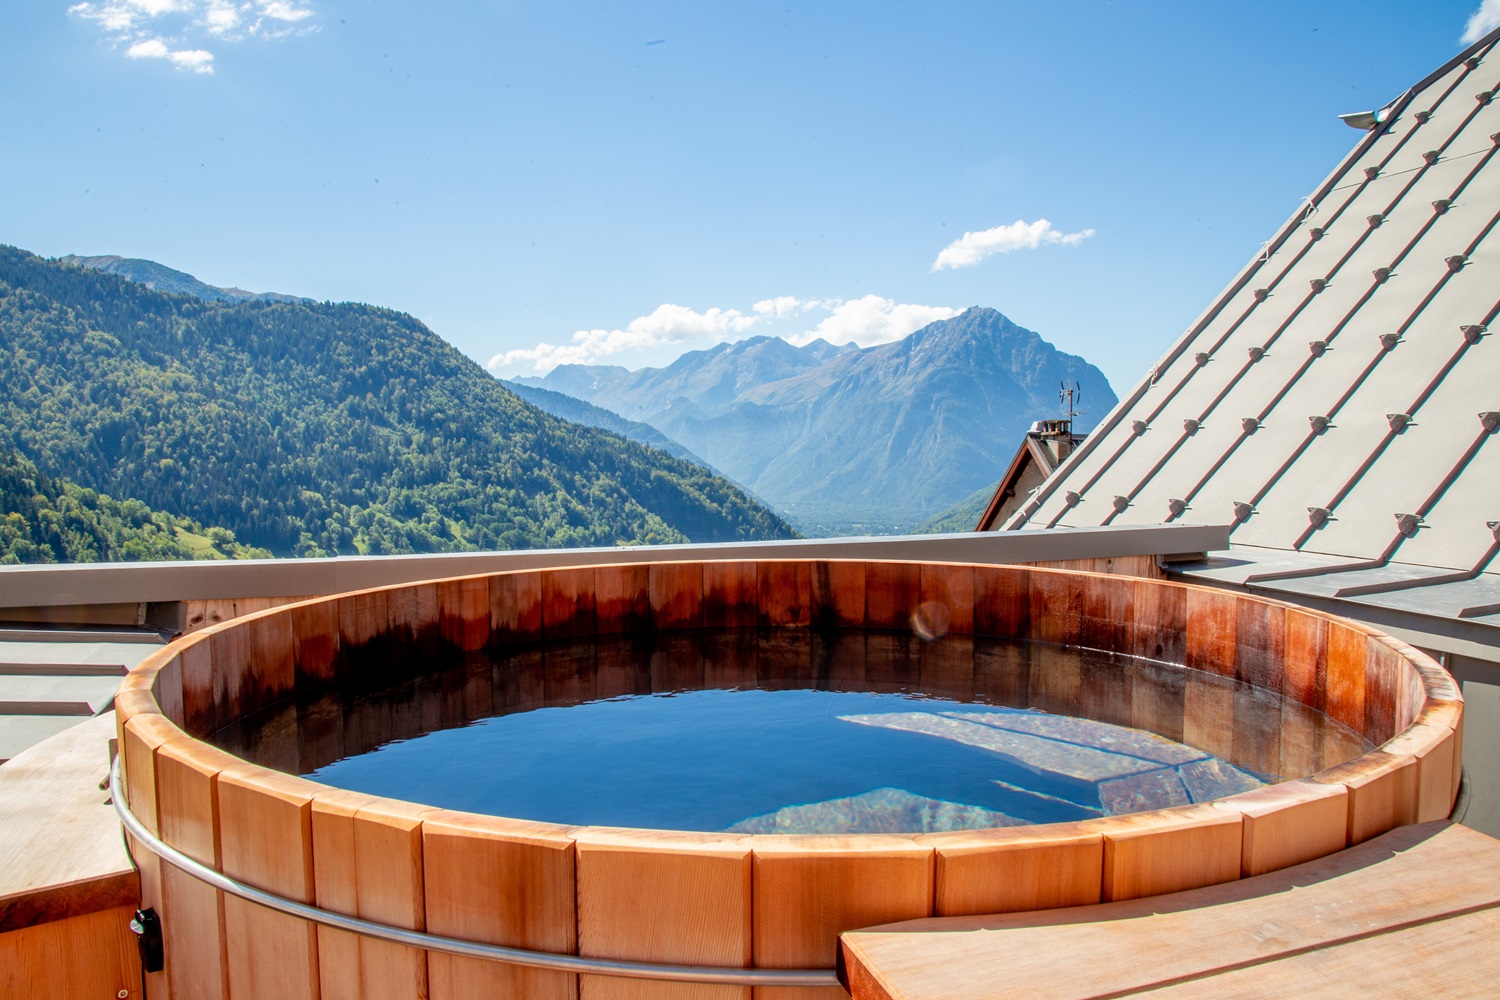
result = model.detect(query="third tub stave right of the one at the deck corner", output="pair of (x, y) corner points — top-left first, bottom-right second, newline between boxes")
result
(1214, 781), (1349, 879)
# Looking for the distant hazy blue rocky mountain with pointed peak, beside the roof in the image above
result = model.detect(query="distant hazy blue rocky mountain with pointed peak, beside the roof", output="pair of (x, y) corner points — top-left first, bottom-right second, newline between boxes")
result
(519, 307), (1115, 532)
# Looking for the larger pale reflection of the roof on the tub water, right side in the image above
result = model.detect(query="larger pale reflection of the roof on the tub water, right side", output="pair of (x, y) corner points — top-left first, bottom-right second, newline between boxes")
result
(846, 712), (1265, 816)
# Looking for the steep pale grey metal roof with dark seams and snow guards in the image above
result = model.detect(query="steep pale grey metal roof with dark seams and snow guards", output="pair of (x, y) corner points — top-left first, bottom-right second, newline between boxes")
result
(1007, 31), (1500, 624)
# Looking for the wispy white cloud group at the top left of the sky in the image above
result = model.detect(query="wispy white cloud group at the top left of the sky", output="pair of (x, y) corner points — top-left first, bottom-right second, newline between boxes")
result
(68, 0), (317, 73)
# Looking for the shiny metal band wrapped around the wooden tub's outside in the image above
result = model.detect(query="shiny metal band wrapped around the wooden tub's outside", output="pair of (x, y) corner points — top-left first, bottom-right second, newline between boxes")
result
(110, 757), (840, 987)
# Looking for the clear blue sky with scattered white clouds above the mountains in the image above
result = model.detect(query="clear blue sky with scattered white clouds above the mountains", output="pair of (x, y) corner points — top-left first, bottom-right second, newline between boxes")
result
(0, 0), (1500, 390)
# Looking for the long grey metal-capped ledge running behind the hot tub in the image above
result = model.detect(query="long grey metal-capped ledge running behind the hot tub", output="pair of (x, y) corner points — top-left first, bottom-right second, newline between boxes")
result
(0, 525), (1229, 609)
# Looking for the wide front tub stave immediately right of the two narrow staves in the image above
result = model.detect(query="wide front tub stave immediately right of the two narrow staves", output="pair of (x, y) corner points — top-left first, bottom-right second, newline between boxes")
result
(422, 811), (578, 1000)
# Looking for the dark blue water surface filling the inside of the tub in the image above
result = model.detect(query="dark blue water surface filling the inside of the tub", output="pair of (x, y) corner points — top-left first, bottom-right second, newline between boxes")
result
(216, 630), (1368, 832)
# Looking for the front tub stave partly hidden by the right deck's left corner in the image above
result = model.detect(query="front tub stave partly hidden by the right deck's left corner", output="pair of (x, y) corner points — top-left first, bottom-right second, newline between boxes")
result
(752, 835), (933, 1000)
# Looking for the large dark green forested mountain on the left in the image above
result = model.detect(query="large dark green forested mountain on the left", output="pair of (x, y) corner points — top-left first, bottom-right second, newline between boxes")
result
(0, 247), (794, 555)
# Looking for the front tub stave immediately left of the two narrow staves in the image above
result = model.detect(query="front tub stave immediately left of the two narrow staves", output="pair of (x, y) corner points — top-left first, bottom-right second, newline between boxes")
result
(218, 765), (321, 1000)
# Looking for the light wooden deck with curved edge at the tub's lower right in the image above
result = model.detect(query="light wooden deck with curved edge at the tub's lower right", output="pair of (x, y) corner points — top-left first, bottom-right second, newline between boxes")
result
(842, 822), (1500, 1000)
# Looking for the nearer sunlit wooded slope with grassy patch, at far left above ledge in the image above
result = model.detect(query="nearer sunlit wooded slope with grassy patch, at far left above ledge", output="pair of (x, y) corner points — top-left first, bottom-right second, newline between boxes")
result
(0, 448), (270, 564)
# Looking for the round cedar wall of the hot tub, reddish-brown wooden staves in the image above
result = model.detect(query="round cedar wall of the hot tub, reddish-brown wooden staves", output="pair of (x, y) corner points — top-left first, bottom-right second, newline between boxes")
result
(117, 561), (1463, 999)
